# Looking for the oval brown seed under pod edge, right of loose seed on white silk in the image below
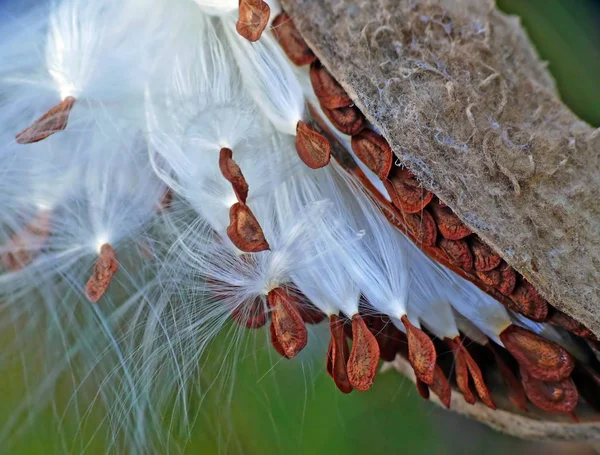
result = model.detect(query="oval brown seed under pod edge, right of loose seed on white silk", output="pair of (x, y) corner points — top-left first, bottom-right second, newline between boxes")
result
(351, 128), (394, 181)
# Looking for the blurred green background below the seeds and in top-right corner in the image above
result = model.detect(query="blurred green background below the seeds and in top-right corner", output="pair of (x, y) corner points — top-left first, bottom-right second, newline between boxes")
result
(0, 0), (600, 455)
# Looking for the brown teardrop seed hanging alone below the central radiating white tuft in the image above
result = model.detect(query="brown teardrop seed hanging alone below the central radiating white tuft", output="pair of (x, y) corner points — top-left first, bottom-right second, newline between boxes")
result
(267, 288), (308, 359)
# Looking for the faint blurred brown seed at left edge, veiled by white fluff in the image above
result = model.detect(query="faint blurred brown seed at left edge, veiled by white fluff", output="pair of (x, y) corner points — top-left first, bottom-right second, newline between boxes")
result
(0, 210), (50, 272)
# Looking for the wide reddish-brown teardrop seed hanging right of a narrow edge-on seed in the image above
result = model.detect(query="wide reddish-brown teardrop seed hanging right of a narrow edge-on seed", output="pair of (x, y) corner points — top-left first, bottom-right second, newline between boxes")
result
(347, 314), (379, 392)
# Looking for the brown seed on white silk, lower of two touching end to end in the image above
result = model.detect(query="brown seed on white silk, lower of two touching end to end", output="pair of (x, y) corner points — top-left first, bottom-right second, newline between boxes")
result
(227, 202), (269, 253)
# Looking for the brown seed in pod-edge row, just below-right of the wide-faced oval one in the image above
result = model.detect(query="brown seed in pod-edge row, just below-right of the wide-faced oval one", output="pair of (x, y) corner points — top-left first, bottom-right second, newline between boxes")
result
(383, 167), (433, 214)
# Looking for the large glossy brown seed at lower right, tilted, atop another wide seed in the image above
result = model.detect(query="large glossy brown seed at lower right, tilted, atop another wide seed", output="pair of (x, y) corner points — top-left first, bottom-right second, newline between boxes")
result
(500, 324), (575, 382)
